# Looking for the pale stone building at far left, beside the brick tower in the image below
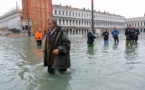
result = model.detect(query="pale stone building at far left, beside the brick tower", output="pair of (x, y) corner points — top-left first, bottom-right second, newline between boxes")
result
(0, 8), (22, 31)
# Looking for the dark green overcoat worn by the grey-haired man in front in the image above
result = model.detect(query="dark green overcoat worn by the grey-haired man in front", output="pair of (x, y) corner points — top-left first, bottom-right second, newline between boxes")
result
(44, 27), (71, 69)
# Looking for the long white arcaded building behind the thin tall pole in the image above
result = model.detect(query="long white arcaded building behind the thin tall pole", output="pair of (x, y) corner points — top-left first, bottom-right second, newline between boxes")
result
(53, 5), (125, 35)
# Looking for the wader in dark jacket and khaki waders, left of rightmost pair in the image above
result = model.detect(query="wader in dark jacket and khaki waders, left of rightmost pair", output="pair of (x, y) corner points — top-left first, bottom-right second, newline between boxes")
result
(125, 24), (135, 46)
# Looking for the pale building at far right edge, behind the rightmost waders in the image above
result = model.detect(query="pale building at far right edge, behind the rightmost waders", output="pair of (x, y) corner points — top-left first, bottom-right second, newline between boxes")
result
(126, 16), (145, 32)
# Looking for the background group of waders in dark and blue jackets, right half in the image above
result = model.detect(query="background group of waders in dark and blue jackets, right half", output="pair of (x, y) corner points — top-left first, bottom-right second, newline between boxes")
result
(87, 24), (140, 46)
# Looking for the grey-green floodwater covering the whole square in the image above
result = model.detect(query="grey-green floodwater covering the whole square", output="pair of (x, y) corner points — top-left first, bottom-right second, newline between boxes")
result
(0, 33), (145, 90)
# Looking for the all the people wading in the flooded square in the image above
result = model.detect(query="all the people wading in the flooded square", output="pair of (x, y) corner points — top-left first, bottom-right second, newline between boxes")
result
(35, 17), (140, 74)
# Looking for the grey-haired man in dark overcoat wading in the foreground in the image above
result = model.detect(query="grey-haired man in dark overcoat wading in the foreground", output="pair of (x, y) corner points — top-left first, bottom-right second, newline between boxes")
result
(44, 17), (71, 73)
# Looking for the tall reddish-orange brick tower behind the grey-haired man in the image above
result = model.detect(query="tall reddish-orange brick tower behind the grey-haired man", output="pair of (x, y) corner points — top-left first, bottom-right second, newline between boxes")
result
(22, 0), (52, 34)
